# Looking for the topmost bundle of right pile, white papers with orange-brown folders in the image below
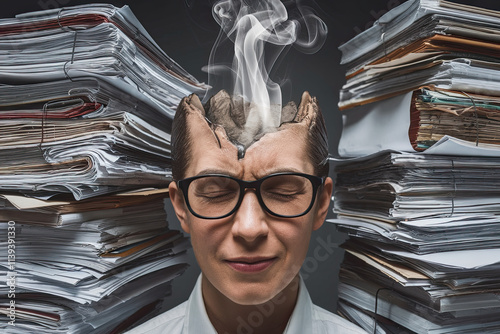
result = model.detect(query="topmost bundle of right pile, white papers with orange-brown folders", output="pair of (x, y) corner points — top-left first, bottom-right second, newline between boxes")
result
(340, 0), (500, 108)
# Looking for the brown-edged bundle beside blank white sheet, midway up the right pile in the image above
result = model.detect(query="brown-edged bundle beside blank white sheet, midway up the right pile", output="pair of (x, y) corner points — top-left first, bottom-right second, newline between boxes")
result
(338, 88), (500, 157)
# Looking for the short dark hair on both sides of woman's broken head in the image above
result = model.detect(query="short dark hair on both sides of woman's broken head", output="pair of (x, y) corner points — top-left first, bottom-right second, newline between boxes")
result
(170, 92), (330, 181)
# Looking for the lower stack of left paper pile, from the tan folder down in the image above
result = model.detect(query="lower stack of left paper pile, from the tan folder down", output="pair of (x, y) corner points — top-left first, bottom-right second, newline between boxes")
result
(0, 189), (189, 333)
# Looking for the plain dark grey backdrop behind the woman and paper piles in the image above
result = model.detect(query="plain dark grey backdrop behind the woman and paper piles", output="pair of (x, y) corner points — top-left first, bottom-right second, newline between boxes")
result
(4, 0), (500, 311)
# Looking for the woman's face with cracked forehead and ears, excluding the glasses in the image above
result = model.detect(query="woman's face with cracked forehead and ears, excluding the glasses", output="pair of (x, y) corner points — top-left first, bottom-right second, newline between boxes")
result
(170, 109), (332, 305)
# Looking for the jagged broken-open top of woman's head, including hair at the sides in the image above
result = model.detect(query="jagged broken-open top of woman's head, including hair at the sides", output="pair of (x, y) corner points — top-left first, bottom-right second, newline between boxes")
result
(172, 91), (328, 180)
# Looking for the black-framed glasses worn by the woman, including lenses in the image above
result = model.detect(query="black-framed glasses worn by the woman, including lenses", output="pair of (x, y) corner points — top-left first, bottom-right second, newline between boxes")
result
(177, 173), (324, 219)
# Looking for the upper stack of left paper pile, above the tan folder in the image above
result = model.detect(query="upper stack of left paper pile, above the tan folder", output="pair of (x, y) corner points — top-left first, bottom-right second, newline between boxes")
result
(0, 5), (207, 199)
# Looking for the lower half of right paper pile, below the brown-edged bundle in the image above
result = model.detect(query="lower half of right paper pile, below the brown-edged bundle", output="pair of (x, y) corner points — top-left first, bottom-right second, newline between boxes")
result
(331, 151), (500, 333)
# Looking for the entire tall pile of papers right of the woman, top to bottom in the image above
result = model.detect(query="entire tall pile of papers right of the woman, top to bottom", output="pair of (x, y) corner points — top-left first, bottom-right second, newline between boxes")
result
(330, 0), (500, 333)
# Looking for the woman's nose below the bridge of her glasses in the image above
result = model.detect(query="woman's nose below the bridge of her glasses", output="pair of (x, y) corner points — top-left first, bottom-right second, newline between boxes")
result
(232, 190), (269, 242)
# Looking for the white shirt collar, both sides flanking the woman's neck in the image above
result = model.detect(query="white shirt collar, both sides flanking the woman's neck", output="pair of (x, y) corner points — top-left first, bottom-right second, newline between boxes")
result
(182, 274), (313, 334)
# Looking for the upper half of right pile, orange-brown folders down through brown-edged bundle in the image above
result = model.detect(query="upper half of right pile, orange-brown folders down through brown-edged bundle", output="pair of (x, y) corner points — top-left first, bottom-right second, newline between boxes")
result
(339, 0), (500, 157)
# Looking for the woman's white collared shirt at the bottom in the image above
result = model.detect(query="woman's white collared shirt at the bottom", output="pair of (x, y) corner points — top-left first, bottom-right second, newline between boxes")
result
(125, 275), (366, 334)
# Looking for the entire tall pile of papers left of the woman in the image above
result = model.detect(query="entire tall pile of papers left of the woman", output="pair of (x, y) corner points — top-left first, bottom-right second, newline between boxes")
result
(0, 5), (207, 334)
